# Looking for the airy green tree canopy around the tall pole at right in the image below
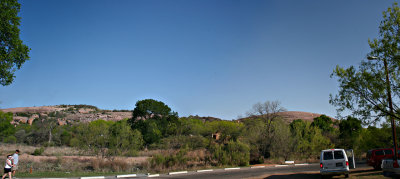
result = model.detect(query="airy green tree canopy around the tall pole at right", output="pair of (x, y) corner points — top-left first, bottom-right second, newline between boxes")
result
(330, 3), (400, 124)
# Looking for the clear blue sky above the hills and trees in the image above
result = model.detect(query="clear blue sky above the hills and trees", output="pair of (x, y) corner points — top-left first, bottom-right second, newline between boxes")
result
(0, 0), (393, 119)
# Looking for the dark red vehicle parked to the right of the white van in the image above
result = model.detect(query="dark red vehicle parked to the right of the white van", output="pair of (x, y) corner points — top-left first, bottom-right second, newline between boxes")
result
(367, 149), (394, 170)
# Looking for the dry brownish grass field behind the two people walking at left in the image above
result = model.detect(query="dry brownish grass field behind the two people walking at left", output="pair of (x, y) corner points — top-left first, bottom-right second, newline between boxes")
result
(0, 144), (149, 172)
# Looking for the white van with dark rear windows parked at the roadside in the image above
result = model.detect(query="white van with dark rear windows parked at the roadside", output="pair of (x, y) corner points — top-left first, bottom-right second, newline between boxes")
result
(320, 149), (355, 178)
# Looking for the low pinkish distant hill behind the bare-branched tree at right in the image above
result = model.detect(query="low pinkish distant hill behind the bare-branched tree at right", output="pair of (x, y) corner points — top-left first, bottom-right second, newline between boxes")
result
(238, 111), (336, 123)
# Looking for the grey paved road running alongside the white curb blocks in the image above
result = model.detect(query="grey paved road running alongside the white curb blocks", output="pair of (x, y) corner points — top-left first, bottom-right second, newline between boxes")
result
(152, 164), (371, 179)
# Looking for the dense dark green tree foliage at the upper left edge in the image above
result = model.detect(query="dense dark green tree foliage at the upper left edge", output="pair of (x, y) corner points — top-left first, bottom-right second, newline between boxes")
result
(0, 0), (30, 86)
